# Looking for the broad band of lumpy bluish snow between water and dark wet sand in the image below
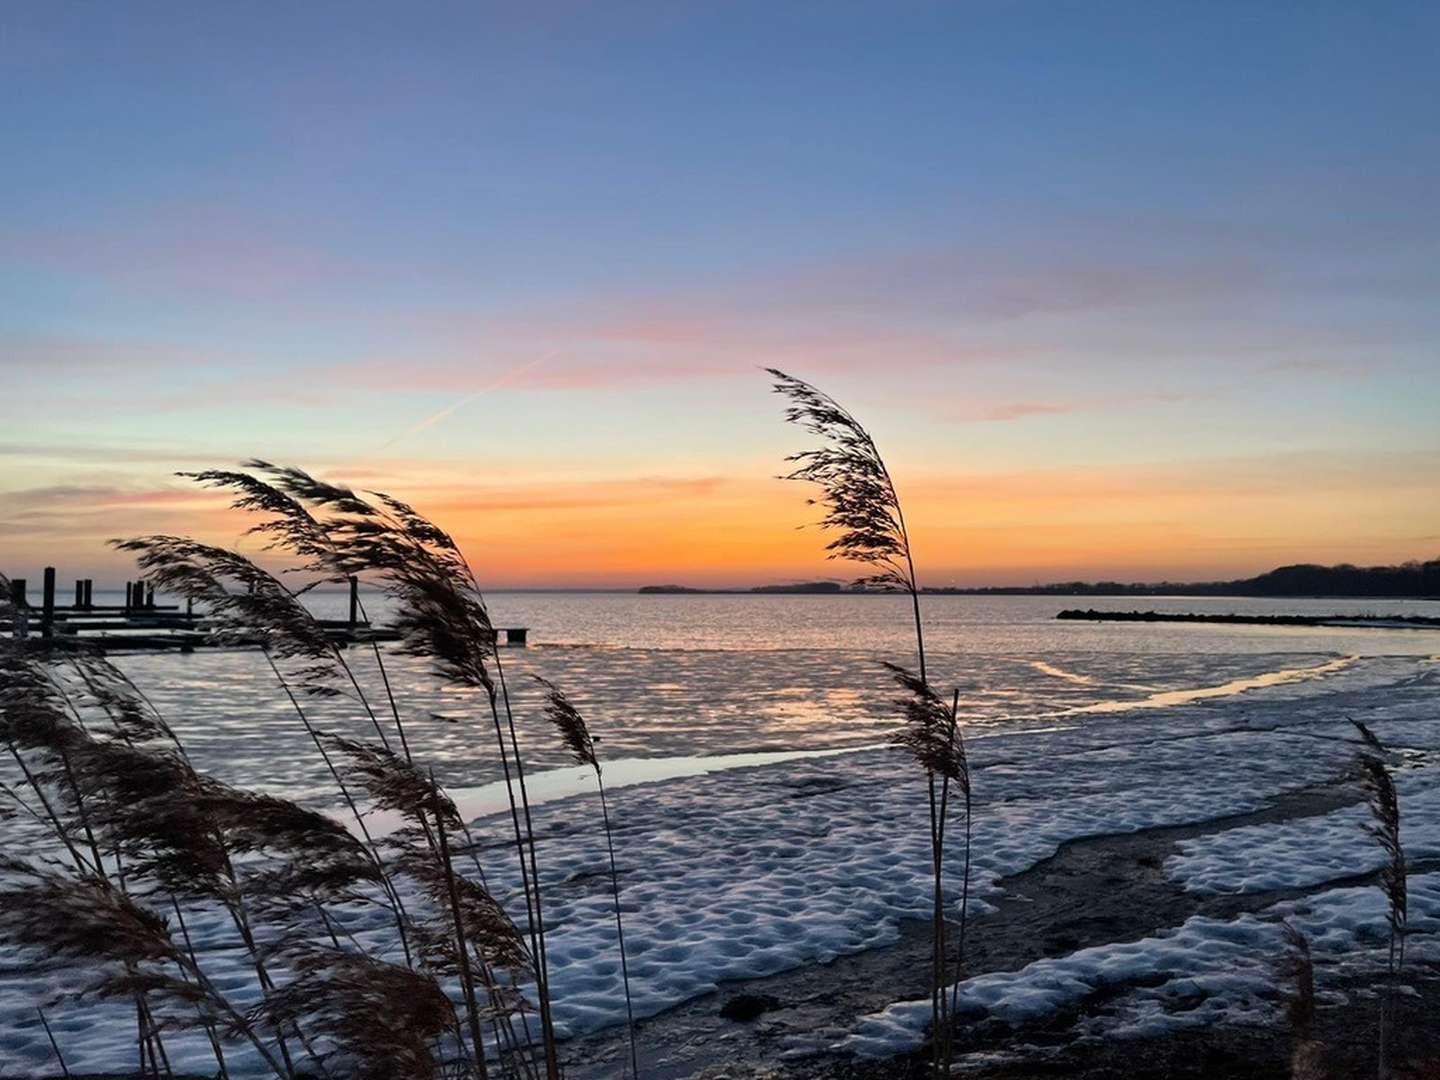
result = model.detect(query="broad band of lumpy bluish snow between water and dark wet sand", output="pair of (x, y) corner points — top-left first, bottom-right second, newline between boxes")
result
(504, 650), (1434, 1034)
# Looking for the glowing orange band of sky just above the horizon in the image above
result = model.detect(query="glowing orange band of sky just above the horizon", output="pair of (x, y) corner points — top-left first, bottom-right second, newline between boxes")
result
(0, 456), (1437, 588)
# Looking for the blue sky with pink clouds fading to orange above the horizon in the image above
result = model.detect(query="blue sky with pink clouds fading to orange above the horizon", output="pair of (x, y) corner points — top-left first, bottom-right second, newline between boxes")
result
(0, 0), (1440, 588)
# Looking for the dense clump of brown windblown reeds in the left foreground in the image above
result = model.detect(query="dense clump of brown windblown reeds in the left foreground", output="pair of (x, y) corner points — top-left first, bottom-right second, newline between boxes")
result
(0, 462), (638, 1080)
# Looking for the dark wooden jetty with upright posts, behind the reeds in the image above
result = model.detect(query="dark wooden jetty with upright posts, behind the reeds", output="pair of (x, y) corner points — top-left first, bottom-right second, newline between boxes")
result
(0, 576), (530, 652)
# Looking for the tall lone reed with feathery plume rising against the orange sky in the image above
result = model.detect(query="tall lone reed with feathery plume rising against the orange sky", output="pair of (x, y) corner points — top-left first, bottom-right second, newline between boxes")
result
(766, 367), (971, 1076)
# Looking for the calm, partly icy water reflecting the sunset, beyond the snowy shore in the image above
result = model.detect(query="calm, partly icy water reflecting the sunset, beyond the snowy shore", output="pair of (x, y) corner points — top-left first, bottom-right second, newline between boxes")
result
(104, 593), (1440, 796)
